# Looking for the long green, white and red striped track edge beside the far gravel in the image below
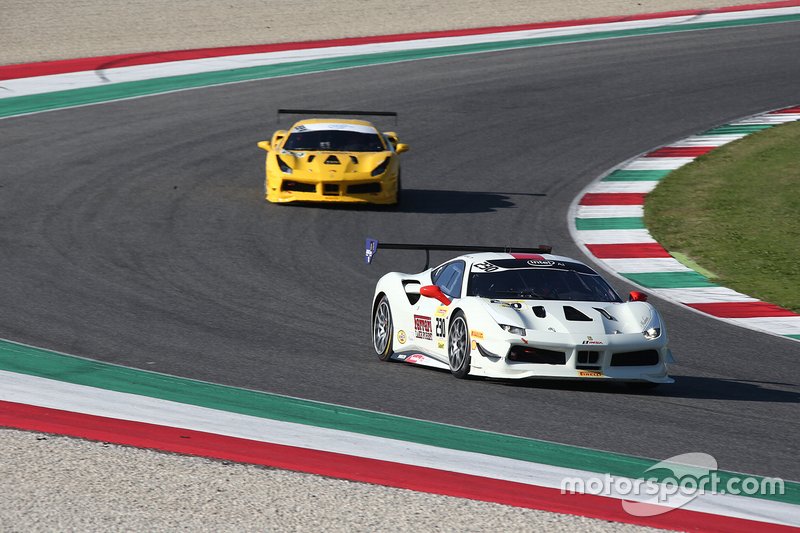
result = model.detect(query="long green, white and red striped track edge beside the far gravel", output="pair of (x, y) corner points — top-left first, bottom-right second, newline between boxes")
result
(0, 7), (800, 118)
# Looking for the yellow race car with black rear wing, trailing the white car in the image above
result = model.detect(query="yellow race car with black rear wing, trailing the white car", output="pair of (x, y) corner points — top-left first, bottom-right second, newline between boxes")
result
(258, 109), (408, 204)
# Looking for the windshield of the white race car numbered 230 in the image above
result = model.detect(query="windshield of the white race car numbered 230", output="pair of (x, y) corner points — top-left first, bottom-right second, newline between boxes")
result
(467, 267), (622, 302)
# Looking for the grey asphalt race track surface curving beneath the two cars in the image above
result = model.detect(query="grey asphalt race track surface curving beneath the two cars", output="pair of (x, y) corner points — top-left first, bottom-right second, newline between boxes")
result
(0, 23), (800, 479)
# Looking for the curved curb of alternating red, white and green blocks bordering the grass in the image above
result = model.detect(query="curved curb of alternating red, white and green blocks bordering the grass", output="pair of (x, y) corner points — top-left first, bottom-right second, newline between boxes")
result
(570, 106), (800, 340)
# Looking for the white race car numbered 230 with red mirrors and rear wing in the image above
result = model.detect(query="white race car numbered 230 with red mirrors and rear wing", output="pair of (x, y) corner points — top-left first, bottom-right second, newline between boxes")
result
(366, 239), (675, 387)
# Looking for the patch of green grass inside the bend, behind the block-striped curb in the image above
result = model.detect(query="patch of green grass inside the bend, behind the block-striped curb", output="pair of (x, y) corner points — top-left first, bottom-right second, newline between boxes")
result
(644, 122), (800, 312)
